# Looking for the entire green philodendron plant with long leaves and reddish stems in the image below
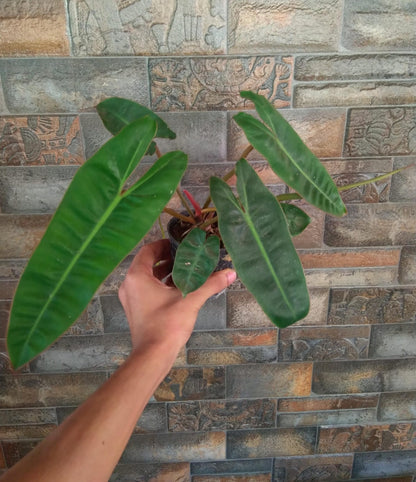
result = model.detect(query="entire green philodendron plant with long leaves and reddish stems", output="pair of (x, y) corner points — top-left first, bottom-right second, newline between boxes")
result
(7, 92), (410, 368)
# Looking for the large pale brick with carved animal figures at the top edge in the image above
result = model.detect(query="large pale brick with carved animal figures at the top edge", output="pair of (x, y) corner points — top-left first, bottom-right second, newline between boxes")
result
(68, 0), (226, 56)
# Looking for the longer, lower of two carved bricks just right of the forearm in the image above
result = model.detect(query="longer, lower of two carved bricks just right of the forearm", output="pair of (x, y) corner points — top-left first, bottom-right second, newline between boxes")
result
(168, 399), (276, 432)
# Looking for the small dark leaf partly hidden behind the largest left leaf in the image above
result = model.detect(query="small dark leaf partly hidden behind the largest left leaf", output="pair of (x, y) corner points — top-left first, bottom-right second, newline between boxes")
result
(97, 97), (176, 138)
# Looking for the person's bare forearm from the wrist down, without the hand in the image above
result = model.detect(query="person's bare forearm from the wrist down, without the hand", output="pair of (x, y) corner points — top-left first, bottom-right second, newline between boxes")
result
(2, 340), (178, 482)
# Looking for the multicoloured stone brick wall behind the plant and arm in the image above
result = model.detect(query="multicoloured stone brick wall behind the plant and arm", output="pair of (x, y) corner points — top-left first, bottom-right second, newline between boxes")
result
(0, 0), (416, 482)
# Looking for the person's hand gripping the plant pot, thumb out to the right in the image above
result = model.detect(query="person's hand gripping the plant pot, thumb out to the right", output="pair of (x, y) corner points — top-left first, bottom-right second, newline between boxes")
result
(119, 239), (236, 352)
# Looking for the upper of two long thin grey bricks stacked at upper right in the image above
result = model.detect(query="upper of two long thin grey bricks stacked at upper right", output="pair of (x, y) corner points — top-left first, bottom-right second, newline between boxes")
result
(295, 54), (416, 81)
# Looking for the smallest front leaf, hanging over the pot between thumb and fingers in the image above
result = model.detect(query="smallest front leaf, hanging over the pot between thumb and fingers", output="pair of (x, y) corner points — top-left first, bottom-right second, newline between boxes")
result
(172, 228), (220, 296)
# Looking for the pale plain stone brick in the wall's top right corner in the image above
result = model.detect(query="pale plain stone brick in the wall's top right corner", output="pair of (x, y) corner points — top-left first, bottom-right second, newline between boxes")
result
(342, 0), (416, 52)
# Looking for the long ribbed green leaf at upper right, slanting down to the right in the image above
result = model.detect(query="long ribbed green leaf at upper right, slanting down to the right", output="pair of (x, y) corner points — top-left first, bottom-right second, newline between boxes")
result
(234, 91), (346, 216)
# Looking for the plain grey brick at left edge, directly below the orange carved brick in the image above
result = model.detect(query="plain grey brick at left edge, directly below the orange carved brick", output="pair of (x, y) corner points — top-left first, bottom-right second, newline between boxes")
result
(0, 166), (77, 214)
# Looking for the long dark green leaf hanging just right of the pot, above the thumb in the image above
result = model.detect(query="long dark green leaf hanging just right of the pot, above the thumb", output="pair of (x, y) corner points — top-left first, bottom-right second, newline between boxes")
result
(210, 159), (309, 327)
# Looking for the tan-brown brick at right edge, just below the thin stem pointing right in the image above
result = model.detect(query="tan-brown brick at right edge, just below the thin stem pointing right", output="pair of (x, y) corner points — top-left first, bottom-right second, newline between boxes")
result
(324, 203), (416, 247)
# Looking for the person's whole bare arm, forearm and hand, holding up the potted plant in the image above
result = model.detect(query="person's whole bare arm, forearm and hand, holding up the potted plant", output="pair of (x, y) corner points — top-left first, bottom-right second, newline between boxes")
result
(1, 240), (236, 482)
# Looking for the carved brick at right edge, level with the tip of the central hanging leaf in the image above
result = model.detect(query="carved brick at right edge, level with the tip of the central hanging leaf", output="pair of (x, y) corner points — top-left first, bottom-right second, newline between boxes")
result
(328, 288), (416, 325)
